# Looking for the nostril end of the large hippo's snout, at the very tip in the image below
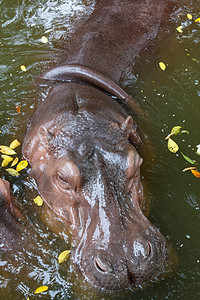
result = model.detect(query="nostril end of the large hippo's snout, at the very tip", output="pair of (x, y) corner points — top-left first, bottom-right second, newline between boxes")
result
(72, 232), (166, 290)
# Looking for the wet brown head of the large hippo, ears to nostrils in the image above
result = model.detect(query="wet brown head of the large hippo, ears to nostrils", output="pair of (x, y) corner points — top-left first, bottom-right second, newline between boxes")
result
(24, 82), (173, 290)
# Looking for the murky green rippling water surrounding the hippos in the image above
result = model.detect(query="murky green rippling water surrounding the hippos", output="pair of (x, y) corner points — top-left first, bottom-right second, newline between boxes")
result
(0, 0), (200, 300)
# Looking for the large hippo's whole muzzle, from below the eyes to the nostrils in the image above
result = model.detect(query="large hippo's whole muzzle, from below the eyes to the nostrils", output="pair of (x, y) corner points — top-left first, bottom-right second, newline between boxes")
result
(72, 180), (169, 290)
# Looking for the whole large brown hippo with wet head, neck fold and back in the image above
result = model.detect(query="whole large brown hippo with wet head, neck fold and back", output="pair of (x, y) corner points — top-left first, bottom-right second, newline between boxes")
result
(0, 0), (177, 290)
